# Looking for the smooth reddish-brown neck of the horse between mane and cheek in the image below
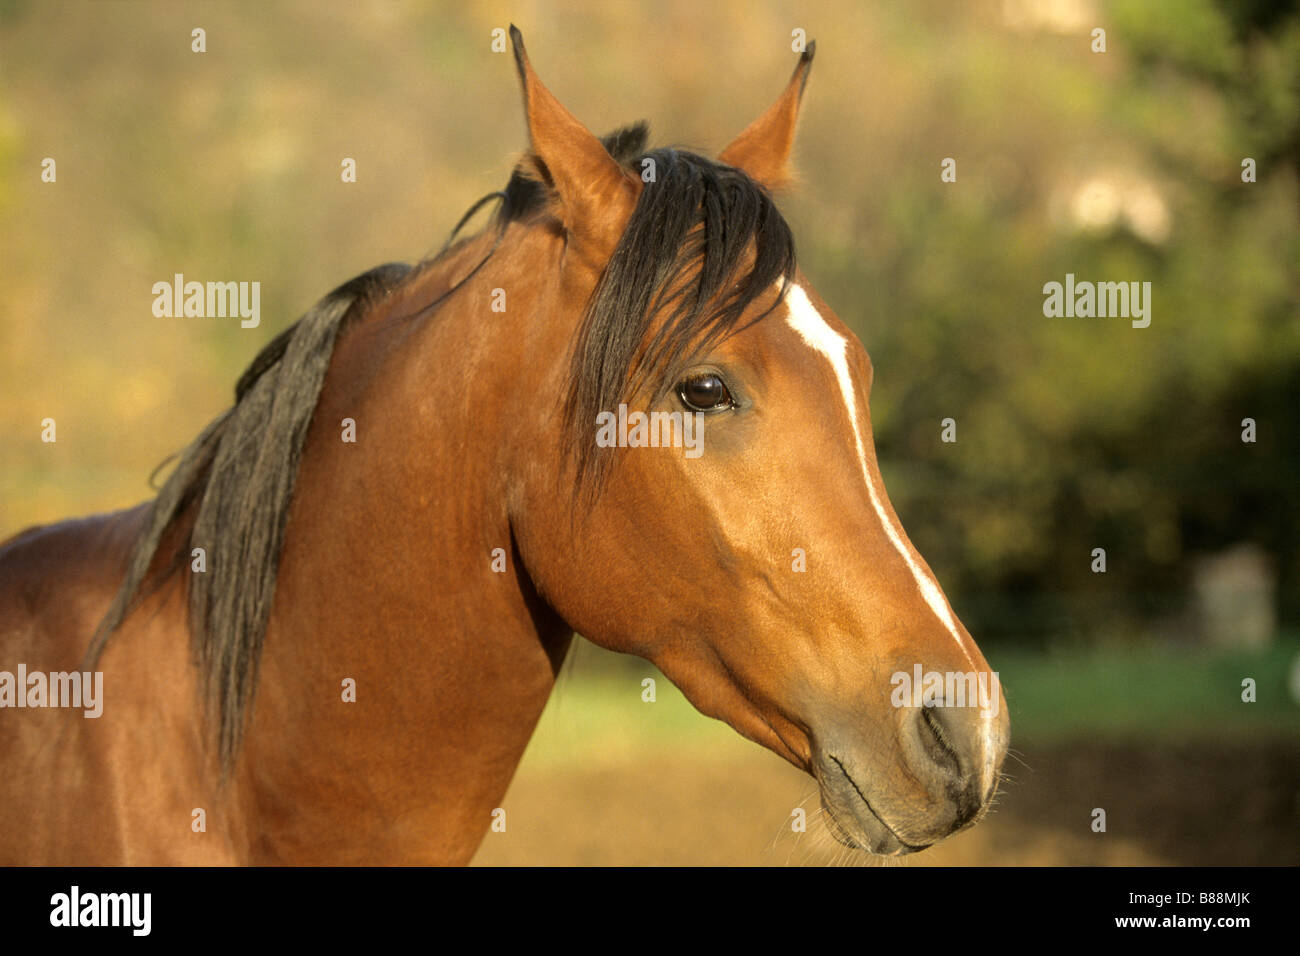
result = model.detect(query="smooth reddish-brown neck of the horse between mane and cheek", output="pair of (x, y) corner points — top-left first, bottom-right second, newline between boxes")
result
(232, 226), (571, 862)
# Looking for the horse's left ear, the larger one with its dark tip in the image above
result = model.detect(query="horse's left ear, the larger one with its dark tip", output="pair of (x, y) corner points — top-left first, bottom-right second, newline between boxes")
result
(510, 23), (641, 265)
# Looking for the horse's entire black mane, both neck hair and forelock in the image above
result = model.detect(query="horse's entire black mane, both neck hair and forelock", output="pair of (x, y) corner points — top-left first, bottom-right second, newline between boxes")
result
(83, 124), (794, 779)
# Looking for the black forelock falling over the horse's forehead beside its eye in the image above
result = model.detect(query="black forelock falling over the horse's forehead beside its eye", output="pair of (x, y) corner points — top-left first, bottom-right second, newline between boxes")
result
(564, 144), (796, 494)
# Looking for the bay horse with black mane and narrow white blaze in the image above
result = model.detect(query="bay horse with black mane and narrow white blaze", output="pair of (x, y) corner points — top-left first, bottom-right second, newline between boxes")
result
(0, 27), (1009, 865)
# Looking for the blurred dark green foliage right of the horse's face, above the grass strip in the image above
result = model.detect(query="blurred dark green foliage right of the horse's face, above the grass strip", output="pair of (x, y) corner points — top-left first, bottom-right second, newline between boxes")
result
(803, 0), (1300, 639)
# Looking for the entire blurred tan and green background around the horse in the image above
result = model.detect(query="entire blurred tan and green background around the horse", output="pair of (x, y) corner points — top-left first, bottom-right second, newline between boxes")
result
(0, 0), (1300, 865)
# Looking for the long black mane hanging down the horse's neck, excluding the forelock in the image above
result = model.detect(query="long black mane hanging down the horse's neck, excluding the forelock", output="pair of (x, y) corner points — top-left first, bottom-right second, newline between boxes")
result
(85, 264), (411, 770)
